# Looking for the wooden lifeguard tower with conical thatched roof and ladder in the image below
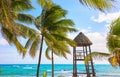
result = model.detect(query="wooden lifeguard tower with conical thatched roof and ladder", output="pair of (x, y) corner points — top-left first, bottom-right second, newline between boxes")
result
(73, 32), (96, 77)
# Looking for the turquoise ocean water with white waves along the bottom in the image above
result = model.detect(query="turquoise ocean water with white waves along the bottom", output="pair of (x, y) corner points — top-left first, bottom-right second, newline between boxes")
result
(0, 64), (120, 77)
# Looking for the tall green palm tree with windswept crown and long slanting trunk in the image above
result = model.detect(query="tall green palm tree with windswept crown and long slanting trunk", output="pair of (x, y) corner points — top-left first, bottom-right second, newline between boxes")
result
(26, 5), (76, 77)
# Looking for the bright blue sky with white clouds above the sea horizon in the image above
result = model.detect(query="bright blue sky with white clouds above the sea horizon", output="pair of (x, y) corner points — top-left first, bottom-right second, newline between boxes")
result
(0, 0), (120, 64)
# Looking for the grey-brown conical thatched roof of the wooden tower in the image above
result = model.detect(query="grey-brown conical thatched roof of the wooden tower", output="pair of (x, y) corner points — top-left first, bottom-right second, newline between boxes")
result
(74, 32), (92, 46)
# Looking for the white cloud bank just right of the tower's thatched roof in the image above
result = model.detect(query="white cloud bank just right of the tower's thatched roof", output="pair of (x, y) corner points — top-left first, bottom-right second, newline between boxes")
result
(86, 32), (108, 52)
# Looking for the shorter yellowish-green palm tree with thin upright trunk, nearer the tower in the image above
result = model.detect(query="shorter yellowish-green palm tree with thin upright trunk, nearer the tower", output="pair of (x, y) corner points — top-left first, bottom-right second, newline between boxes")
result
(46, 40), (75, 77)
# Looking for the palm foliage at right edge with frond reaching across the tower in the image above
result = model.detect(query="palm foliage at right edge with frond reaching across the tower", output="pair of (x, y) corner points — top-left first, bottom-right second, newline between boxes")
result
(85, 18), (120, 67)
